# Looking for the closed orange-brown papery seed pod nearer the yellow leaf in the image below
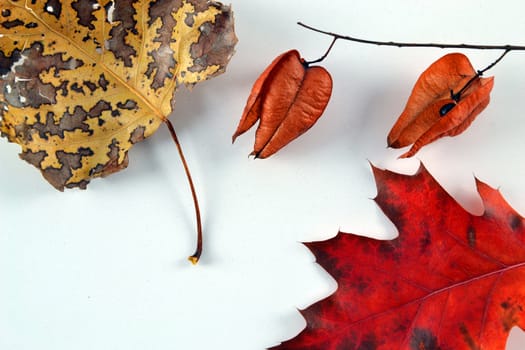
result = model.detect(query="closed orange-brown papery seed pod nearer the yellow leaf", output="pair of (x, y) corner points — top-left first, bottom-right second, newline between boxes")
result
(232, 50), (332, 158)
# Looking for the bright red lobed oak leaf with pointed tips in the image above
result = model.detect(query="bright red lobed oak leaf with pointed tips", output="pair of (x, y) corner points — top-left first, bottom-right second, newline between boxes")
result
(276, 167), (525, 350)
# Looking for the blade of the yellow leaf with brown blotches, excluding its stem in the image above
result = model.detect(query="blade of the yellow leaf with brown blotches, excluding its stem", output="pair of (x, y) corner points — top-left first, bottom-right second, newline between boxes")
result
(0, 0), (237, 190)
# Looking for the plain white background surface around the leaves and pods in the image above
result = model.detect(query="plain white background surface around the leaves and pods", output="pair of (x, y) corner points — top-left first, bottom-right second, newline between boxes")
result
(0, 0), (525, 350)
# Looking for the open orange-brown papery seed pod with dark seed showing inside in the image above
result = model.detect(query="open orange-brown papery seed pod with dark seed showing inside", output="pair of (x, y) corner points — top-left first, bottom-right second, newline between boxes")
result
(388, 53), (494, 158)
